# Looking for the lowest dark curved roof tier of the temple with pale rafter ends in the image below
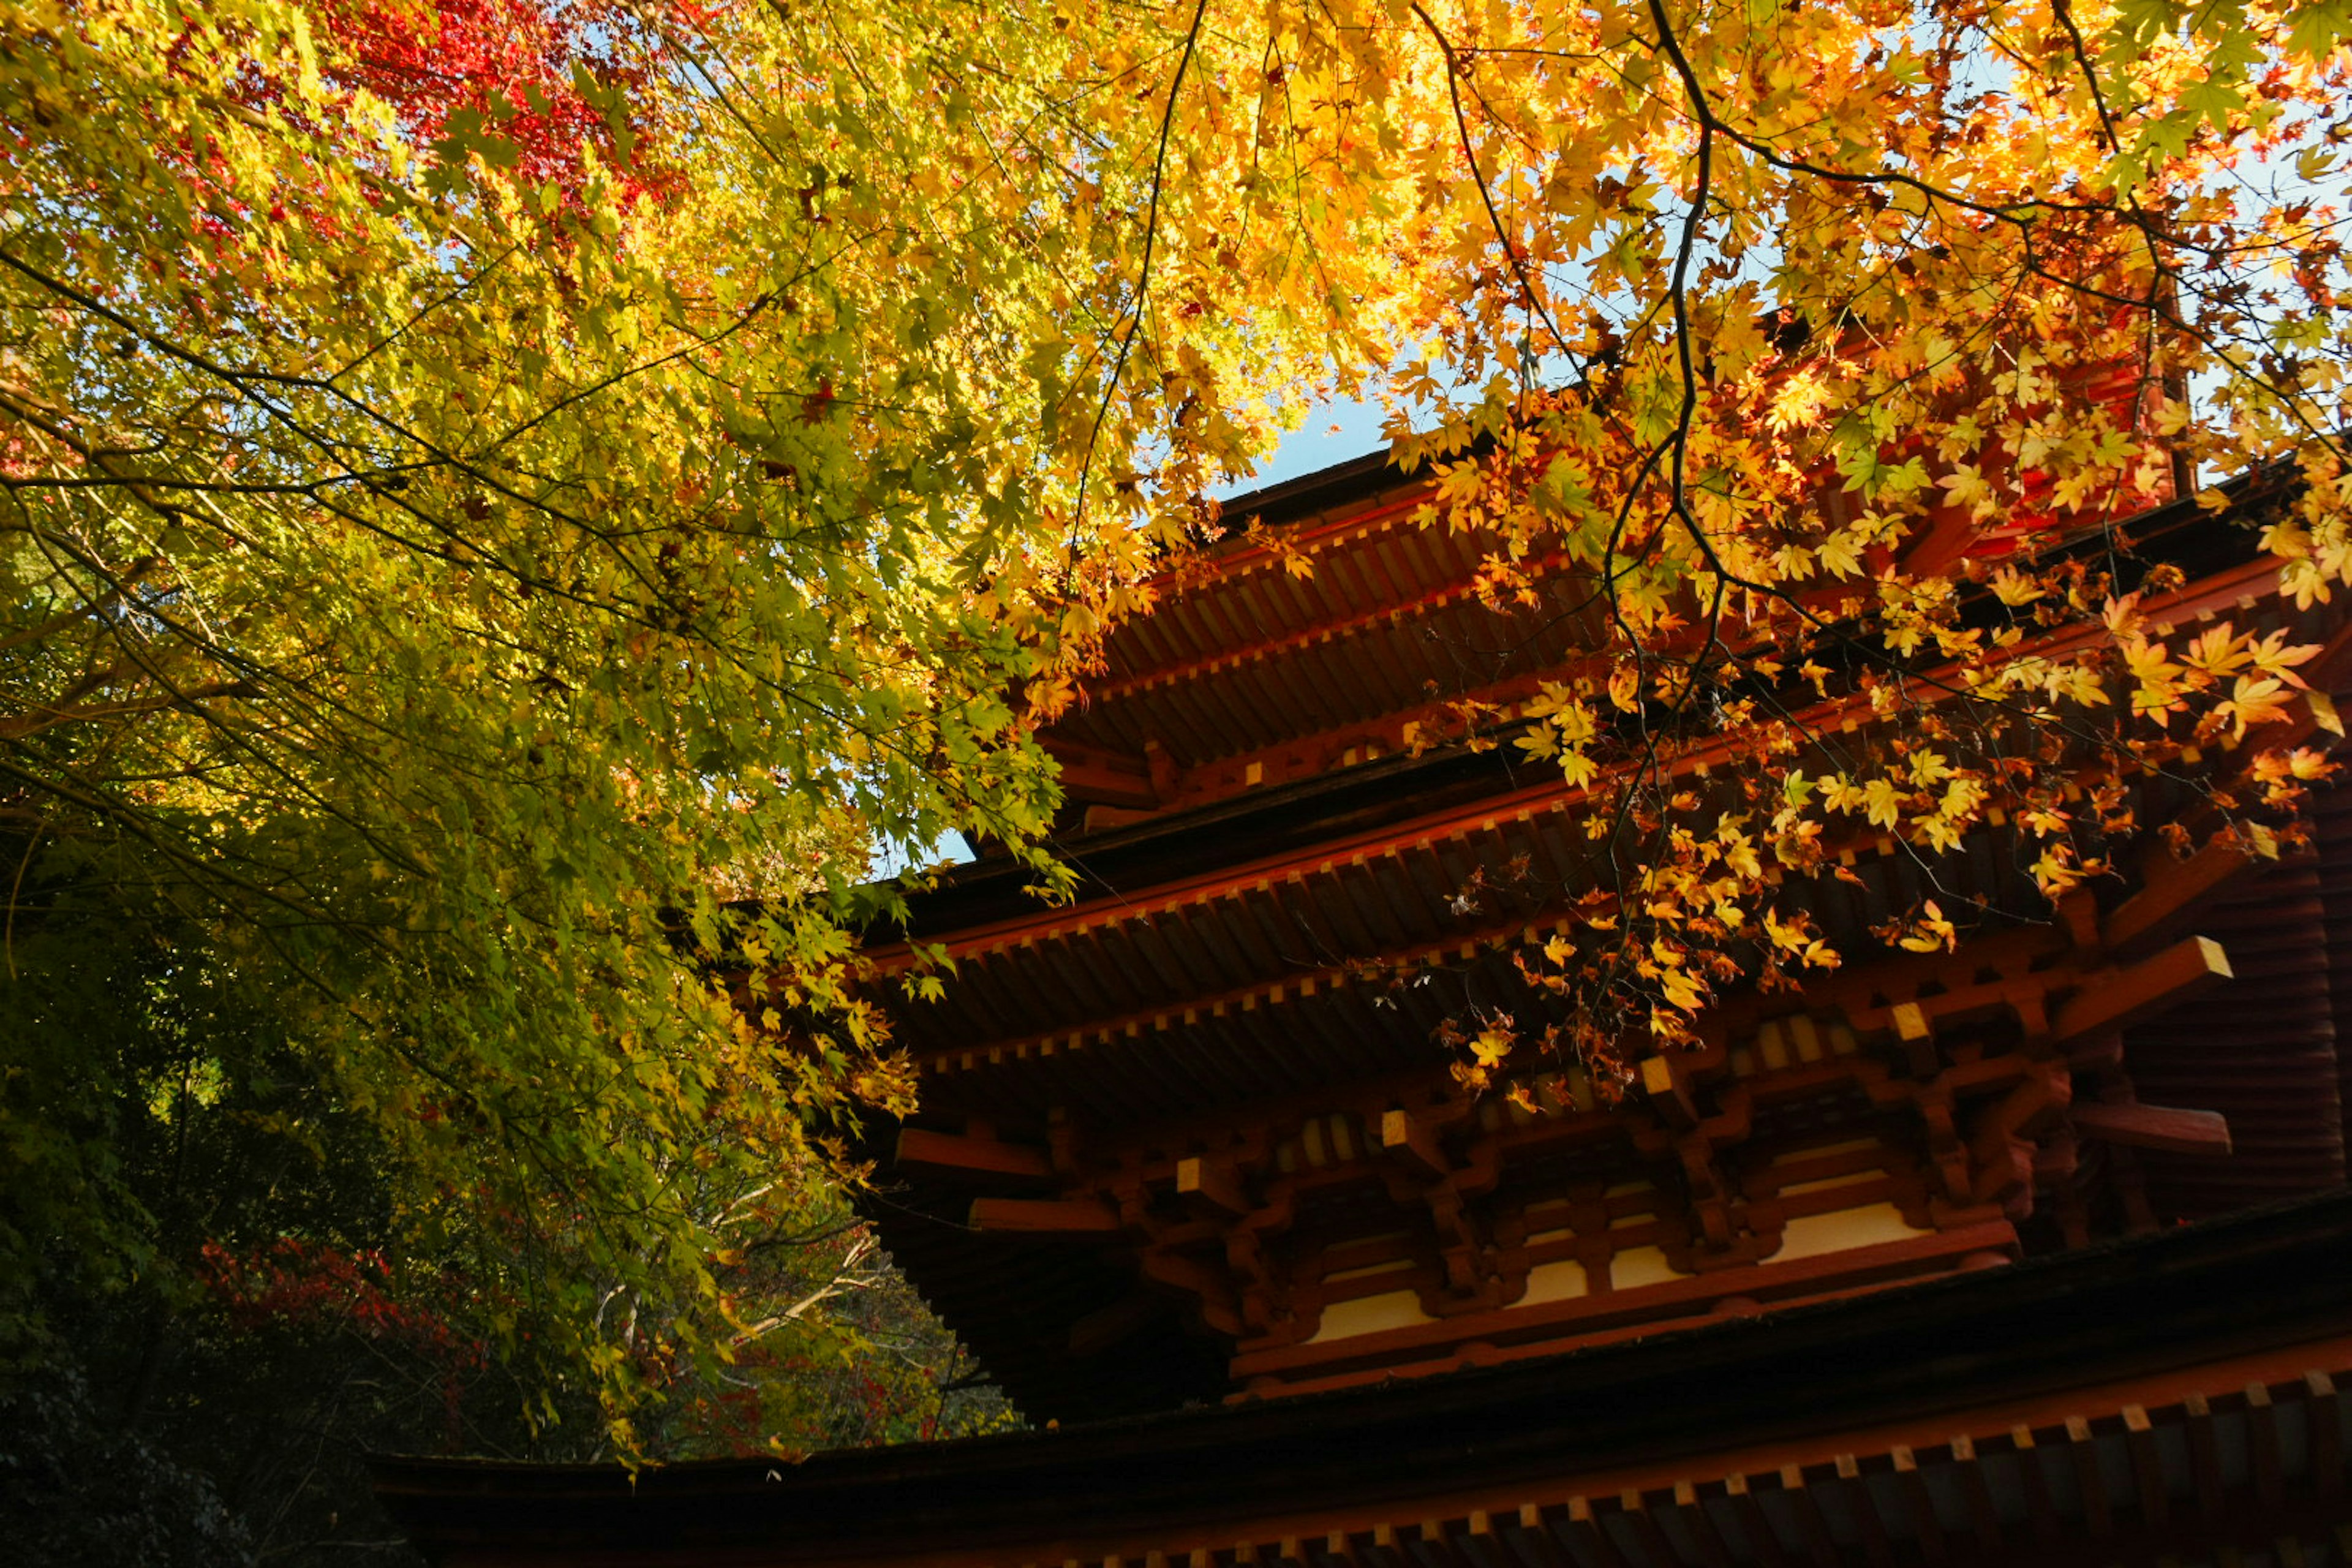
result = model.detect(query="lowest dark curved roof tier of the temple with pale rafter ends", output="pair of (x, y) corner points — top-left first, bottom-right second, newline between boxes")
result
(376, 1192), (2352, 1568)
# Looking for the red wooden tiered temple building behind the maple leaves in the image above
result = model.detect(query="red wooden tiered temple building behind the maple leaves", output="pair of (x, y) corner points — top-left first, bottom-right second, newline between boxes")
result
(379, 442), (2352, 1568)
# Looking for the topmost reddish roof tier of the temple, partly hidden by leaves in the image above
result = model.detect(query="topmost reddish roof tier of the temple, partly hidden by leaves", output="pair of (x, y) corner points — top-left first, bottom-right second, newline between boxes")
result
(1039, 360), (2164, 832)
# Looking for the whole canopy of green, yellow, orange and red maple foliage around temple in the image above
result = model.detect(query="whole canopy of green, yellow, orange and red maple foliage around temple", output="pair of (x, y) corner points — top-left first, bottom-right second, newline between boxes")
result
(0, 0), (2352, 1485)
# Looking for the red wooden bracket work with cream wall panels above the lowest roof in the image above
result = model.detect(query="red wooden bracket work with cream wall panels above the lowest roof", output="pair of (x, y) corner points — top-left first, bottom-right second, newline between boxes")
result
(945, 849), (2260, 1392)
